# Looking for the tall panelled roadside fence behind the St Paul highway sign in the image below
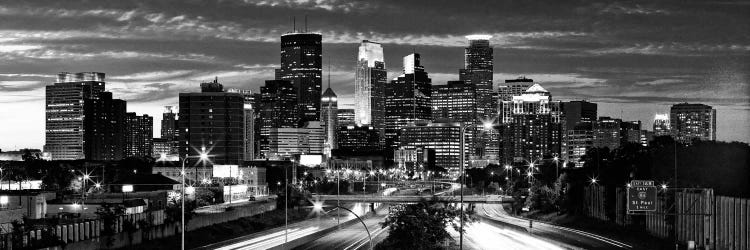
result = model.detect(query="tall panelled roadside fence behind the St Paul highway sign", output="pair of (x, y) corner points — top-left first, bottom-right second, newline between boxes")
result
(583, 186), (750, 250)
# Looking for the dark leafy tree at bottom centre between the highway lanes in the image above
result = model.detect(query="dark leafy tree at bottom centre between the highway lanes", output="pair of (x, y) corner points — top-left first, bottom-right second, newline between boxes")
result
(376, 199), (473, 249)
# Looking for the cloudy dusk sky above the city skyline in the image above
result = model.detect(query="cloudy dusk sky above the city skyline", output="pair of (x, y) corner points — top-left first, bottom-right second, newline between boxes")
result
(0, 0), (750, 150)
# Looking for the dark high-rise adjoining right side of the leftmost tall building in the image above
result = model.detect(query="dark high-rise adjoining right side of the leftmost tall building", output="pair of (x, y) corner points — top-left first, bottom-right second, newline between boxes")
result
(83, 92), (126, 161)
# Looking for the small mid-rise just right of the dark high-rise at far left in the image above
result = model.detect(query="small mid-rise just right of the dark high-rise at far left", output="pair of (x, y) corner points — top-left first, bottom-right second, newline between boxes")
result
(125, 112), (154, 157)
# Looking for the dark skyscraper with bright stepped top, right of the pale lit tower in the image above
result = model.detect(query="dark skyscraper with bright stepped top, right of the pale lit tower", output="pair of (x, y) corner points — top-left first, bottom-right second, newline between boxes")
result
(385, 53), (432, 148)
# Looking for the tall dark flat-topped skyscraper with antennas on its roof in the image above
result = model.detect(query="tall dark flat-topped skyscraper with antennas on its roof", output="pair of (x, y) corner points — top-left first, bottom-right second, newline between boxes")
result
(276, 32), (323, 125)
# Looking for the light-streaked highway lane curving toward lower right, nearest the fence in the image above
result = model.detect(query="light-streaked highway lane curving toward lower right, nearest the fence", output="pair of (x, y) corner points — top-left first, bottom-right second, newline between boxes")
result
(476, 204), (633, 249)
